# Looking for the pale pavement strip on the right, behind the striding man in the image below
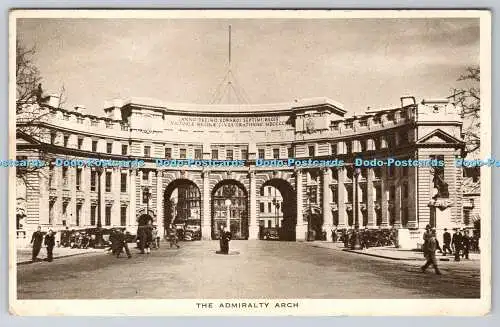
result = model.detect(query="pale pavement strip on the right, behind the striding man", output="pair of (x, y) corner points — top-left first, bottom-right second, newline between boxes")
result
(309, 241), (481, 261)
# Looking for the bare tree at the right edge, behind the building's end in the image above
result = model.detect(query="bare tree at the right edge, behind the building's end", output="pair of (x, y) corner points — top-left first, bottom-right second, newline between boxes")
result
(452, 66), (481, 154)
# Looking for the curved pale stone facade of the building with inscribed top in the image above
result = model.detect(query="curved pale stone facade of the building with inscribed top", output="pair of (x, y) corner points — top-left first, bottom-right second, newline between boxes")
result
(17, 96), (464, 247)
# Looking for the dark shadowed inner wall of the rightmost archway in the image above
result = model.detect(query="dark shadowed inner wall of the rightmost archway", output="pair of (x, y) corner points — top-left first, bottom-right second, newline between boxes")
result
(259, 178), (297, 241)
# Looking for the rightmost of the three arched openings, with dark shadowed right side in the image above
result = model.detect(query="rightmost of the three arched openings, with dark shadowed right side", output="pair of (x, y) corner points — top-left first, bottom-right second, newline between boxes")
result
(257, 178), (297, 241)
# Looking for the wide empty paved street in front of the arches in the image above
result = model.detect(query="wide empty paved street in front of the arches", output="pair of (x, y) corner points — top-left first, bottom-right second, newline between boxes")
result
(17, 241), (480, 299)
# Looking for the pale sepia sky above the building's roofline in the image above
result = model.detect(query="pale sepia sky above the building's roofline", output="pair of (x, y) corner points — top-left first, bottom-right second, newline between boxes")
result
(17, 18), (480, 115)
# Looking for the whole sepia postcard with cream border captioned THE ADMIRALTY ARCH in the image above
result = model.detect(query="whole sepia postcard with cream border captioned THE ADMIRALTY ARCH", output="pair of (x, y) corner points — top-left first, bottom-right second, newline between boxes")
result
(8, 10), (492, 316)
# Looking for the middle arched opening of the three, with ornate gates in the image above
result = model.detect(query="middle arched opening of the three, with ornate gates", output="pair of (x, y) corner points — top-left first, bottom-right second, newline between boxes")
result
(211, 179), (248, 240)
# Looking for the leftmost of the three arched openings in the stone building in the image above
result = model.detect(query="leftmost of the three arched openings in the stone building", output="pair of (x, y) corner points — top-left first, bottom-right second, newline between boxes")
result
(163, 179), (201, 240)
